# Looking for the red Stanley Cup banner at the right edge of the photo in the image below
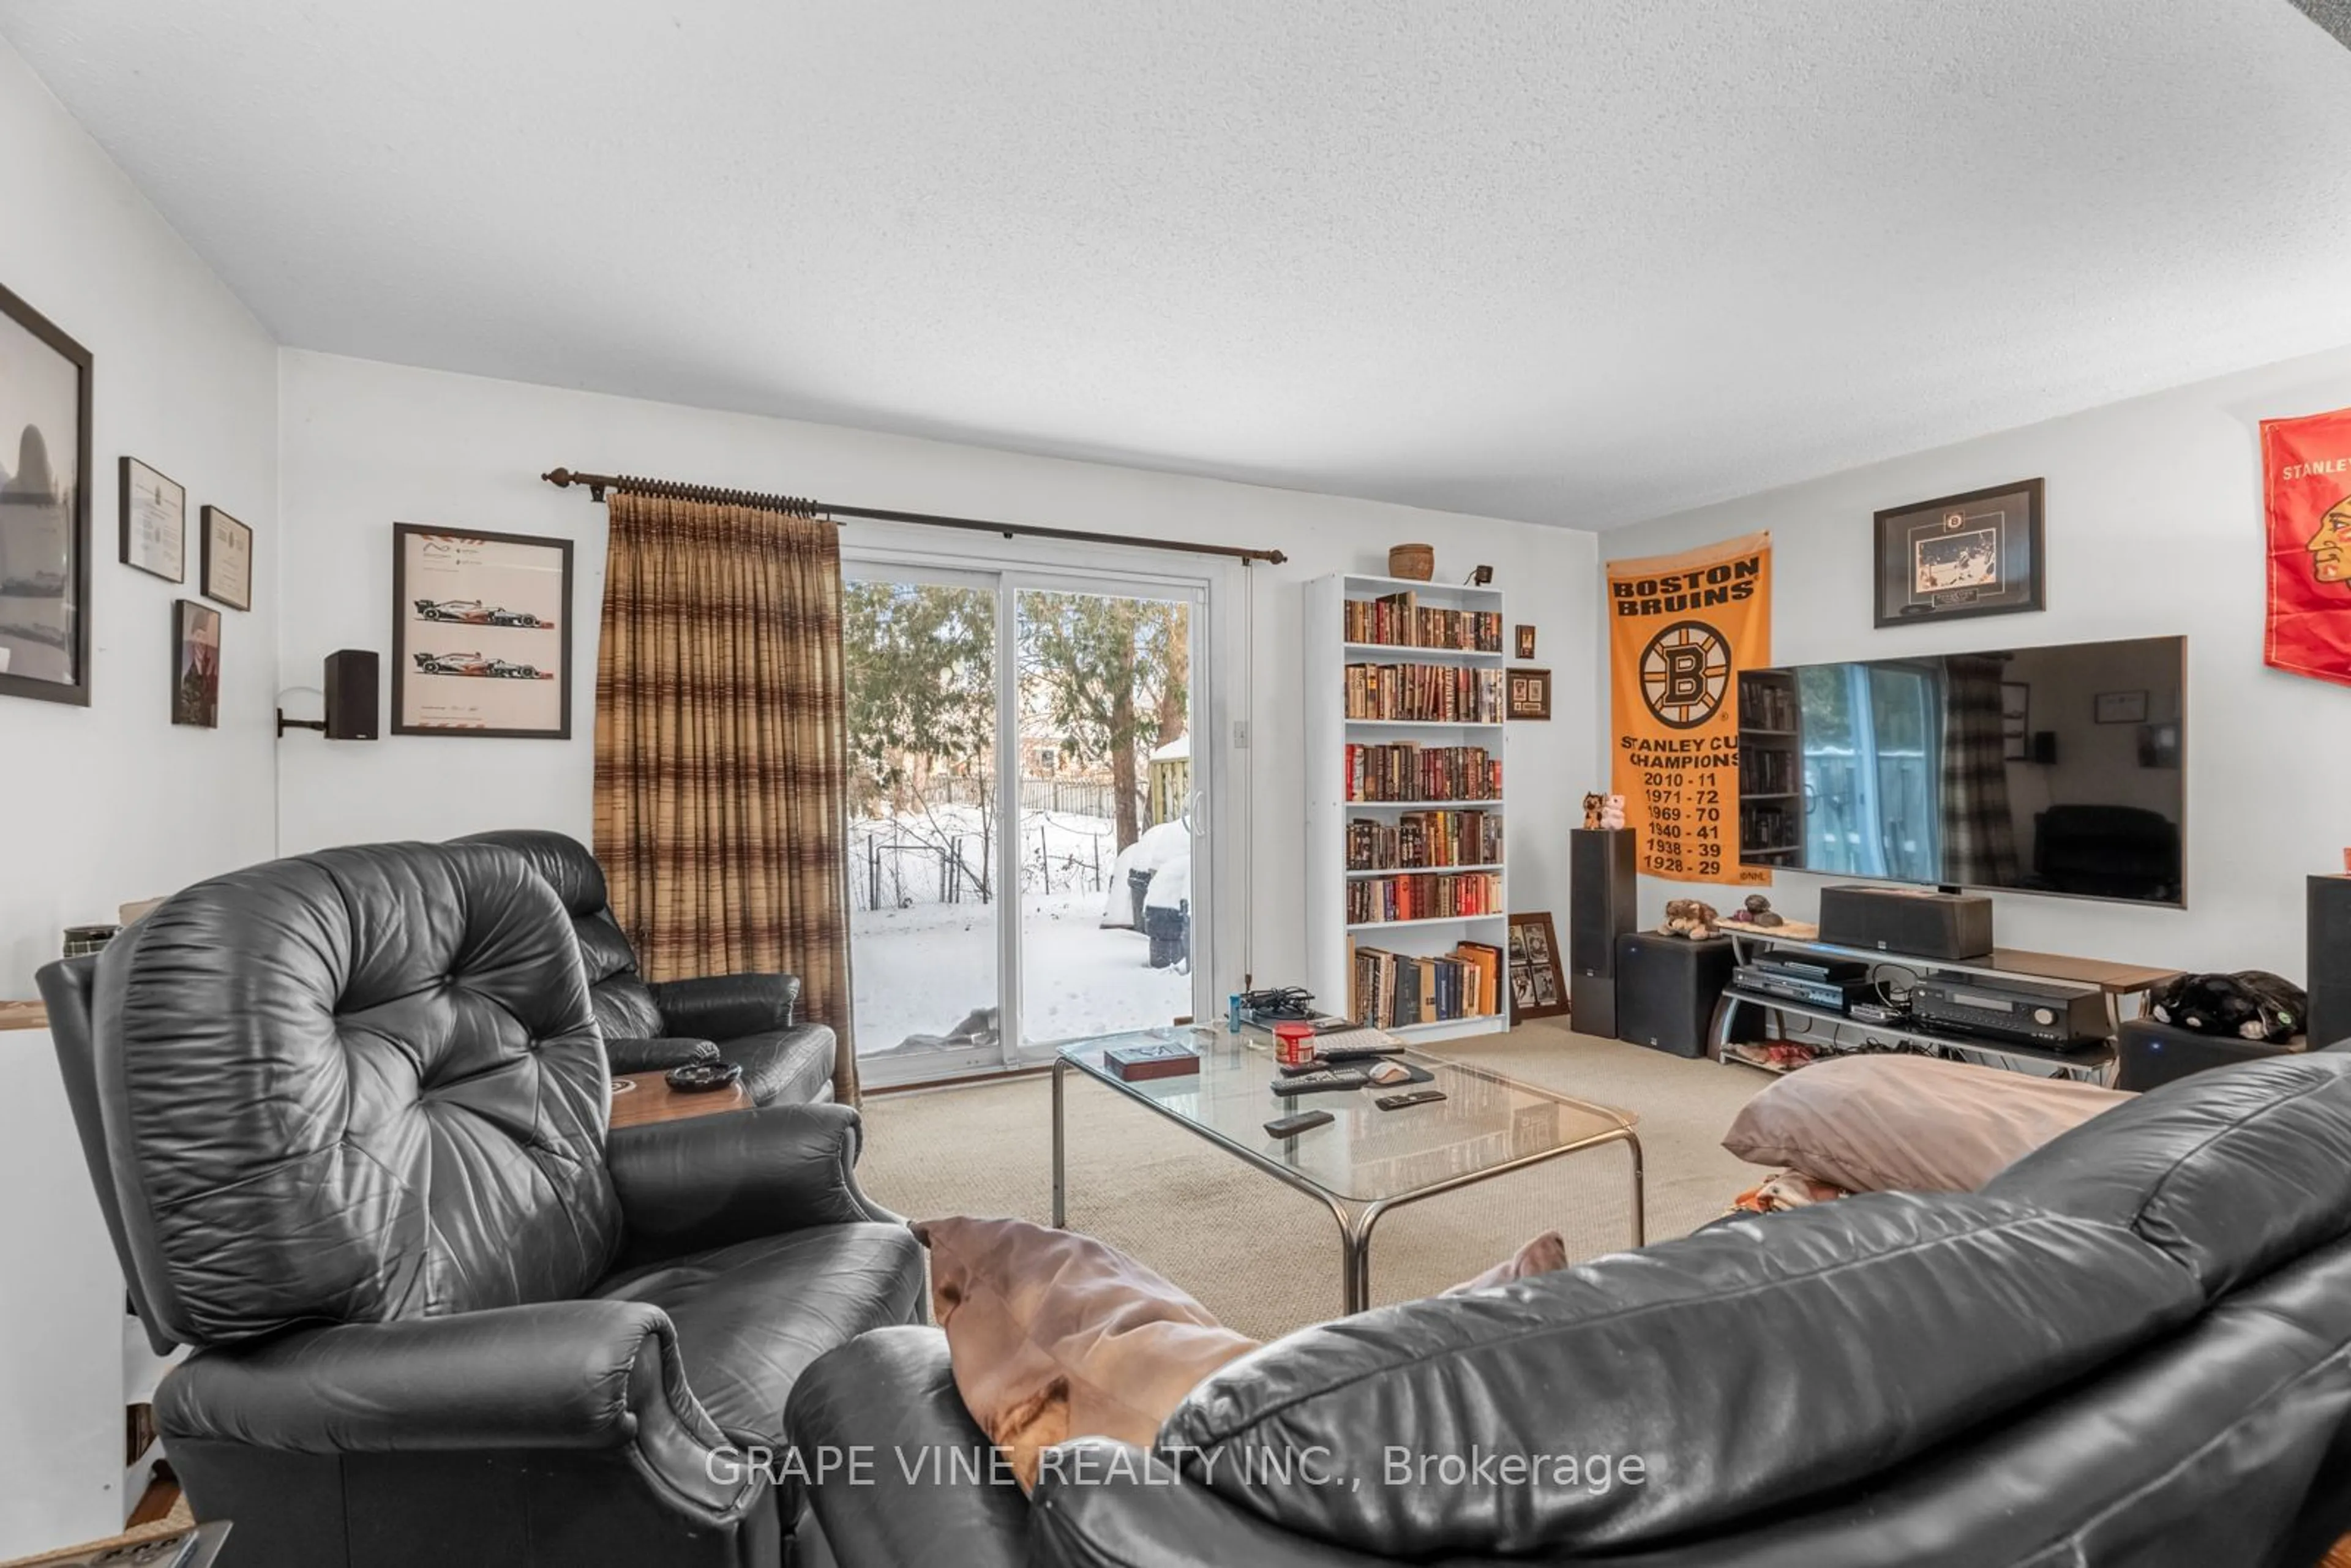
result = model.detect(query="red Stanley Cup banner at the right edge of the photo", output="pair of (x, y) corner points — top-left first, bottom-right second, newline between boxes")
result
(2262, 409), (2351, 686)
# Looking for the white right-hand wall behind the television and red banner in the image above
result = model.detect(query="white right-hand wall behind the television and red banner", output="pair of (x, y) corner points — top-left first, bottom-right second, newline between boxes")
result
(1596, 348), (2351, 980)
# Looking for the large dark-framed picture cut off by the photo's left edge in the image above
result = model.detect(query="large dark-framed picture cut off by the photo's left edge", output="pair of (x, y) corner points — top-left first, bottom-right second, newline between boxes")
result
(0, 289), (89, 708)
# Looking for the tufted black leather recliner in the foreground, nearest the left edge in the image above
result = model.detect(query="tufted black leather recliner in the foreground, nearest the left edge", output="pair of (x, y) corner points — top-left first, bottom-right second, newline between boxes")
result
(39, 844), (921, 1568)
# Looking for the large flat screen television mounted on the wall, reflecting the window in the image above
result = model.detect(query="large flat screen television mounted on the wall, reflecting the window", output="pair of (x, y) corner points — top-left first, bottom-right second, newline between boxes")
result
(1740, 637), (2186, 905)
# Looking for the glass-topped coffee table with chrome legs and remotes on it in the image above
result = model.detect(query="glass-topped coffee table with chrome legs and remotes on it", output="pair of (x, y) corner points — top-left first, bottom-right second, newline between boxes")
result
(1053, 1027), (1643, 1311)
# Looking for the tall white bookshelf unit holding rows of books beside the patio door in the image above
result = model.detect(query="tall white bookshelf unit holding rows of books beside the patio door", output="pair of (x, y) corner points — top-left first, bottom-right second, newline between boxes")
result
(1305, 574), (1519, 1041)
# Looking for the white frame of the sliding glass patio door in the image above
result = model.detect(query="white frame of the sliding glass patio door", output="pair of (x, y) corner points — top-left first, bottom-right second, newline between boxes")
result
(842, 524), (1239, 1086)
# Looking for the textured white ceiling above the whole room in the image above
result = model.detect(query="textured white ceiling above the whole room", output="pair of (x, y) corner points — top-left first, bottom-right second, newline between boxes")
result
(0, 0), (2351, 527)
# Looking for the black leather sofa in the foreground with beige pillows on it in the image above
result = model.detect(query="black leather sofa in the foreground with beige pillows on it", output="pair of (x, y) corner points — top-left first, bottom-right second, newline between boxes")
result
(790, 1053), (2351, 1568)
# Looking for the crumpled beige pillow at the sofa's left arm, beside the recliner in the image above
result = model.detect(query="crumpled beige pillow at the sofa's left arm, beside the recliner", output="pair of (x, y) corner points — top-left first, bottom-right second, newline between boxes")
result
(915, 1218), (1258, 1488)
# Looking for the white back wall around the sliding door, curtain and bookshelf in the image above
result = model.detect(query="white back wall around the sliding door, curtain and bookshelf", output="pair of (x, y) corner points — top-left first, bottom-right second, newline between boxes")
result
(280, 350), (1599, 1001)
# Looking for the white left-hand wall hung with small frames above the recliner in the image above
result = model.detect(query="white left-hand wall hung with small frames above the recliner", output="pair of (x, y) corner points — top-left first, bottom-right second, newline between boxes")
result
(0, 42), (282, 997)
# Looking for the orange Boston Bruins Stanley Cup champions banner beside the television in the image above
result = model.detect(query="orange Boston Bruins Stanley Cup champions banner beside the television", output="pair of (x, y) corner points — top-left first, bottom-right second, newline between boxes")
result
(1608, 534), (1771, 887)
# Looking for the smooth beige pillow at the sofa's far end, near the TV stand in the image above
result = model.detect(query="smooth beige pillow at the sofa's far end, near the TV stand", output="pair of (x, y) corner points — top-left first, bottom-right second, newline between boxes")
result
(1723, 1053), (2132, 1192)
